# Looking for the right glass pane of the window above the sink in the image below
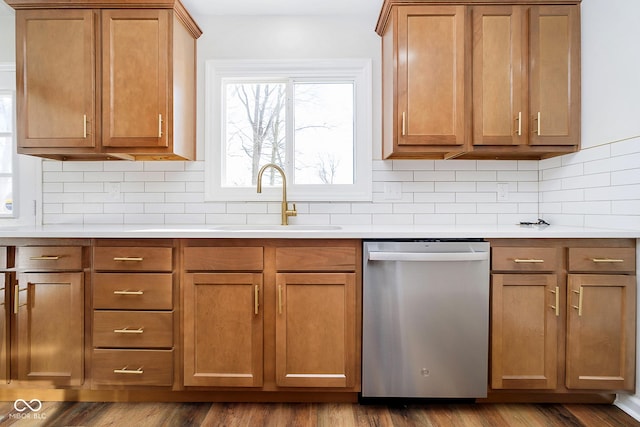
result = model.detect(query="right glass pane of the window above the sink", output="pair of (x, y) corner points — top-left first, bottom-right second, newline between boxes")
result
(294, 83), (354, 184)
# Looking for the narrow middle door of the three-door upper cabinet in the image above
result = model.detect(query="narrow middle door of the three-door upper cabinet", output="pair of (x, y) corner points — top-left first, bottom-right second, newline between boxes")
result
(472, 6), (528, 145)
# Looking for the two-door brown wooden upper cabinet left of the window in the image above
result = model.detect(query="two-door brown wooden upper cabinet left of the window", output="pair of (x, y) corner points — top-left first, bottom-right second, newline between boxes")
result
(7, 0), (202, 160)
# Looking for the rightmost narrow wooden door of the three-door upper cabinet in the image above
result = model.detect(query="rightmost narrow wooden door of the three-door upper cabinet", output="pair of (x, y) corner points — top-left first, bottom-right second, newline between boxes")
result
(529, 6), (580, 145)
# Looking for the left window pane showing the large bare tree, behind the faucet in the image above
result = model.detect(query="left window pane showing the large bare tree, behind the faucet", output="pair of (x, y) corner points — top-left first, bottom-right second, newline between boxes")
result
(222, 82), (286, 187)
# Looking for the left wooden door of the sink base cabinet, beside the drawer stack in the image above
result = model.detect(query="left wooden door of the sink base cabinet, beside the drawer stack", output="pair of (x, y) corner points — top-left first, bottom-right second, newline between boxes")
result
(184, 273), (264, 387)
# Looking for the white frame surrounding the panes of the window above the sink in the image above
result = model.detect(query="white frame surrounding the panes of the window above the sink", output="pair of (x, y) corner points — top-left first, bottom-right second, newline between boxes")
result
(205, 59), (372, 201)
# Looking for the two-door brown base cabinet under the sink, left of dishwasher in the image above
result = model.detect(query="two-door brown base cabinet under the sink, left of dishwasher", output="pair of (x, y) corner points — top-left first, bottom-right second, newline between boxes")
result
(183, 240), (361, 392)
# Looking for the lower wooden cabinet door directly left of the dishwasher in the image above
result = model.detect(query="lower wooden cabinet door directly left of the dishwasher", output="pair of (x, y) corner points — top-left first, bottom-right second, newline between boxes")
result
(276, 273), (357, 388)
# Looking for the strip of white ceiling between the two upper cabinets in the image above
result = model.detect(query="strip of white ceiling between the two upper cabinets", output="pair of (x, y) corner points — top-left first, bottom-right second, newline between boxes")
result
(182, 0), (382, 16)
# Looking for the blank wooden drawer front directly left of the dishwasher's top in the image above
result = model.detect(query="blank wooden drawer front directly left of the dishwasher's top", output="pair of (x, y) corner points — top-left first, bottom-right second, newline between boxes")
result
(276, 247), (357, 271)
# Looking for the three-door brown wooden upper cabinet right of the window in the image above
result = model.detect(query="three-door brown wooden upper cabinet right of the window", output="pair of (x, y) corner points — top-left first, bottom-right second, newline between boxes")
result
(376, 0), (580, 159)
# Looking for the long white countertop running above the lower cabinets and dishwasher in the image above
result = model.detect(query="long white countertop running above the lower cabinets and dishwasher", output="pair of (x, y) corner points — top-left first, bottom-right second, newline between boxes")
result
(0, 224), (640, 239)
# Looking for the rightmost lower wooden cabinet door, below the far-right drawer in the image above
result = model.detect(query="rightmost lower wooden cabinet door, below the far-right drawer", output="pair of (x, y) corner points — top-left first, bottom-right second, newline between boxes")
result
(566, 274), (636, 391)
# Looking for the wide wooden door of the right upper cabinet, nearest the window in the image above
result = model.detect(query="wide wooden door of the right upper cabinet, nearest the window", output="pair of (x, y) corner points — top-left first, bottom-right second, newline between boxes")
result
(396, 6), (467, 155)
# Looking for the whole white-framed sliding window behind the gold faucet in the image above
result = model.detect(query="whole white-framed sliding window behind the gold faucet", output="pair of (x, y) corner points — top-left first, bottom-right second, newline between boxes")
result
(205, 60), (372, 201)
